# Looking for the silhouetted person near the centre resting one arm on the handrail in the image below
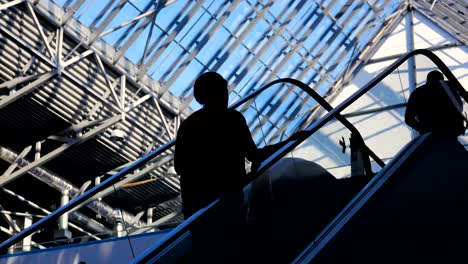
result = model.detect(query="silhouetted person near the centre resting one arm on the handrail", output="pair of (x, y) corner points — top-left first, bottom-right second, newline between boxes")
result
(174, 72), (304, 263)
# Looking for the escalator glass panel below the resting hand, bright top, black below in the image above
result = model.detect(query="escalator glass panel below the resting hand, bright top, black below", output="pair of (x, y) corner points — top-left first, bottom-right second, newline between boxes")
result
(249, 119), (370, 263)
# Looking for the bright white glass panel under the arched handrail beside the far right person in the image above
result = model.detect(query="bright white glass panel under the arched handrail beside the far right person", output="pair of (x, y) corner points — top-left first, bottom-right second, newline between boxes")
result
(342, 59), (413, 165)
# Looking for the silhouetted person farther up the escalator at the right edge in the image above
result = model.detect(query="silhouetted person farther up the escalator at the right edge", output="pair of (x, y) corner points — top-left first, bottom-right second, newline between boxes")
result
(405, 71), (465, 136)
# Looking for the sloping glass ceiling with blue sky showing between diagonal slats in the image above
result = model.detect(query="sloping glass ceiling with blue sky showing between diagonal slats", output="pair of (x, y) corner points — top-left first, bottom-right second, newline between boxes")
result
(54, 0), (401, 143)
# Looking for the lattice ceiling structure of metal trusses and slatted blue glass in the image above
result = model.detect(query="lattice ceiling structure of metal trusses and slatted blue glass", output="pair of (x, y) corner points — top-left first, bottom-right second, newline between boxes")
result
(0, 0), (468, 251)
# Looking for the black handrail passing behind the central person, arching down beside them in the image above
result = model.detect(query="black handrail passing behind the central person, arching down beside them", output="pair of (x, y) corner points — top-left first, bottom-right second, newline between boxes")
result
(0, 71), (376, 252)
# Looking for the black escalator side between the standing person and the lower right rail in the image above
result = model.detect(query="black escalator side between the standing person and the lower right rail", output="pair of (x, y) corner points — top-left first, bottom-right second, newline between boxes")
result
(243, 158), (368, 263)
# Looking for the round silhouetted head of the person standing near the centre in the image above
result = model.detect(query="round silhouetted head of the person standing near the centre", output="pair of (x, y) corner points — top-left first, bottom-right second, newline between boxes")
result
(193, 72), (228, 108)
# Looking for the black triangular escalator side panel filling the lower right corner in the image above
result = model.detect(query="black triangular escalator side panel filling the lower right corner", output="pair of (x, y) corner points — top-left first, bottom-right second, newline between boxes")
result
(312, 135), (468, 263)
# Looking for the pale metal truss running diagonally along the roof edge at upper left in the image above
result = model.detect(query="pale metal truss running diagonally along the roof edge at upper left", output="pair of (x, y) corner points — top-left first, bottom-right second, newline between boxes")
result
(0, 1), (177, 186)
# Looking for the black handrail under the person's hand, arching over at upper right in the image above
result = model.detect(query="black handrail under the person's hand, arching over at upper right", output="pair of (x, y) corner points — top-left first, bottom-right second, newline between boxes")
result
(132, 49), (468, 264)
